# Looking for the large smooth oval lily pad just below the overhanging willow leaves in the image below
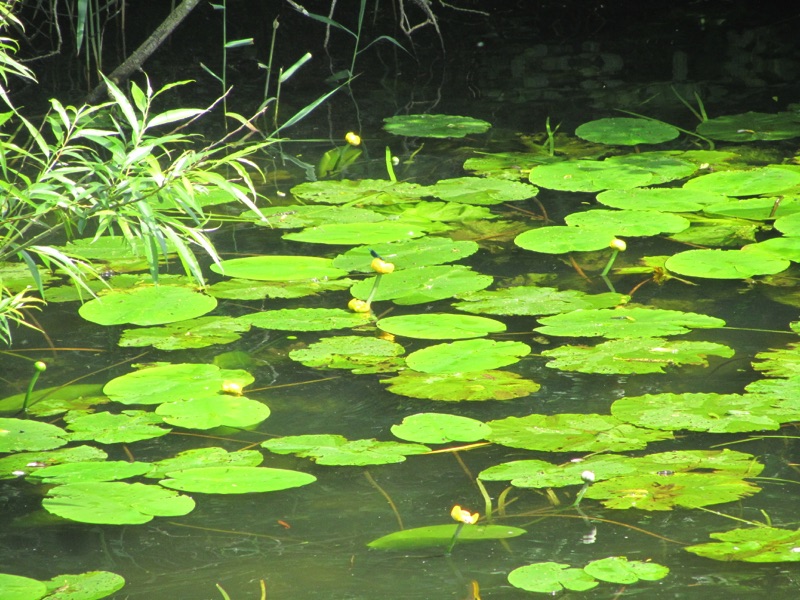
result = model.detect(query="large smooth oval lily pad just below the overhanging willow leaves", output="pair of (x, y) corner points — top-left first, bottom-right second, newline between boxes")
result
(78, 285), (217, 325)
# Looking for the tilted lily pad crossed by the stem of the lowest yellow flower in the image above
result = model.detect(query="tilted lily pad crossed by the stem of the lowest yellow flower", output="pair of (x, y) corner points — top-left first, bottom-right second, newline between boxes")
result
(367, 523), (527, 550)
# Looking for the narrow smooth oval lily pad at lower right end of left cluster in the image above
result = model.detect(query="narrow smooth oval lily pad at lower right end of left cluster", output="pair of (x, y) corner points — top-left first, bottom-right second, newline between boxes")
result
(159, 466), (317, 494)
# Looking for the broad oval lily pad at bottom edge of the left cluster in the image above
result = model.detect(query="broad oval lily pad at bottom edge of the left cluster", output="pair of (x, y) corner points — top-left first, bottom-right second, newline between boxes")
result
(42, 481), (194, 525)
